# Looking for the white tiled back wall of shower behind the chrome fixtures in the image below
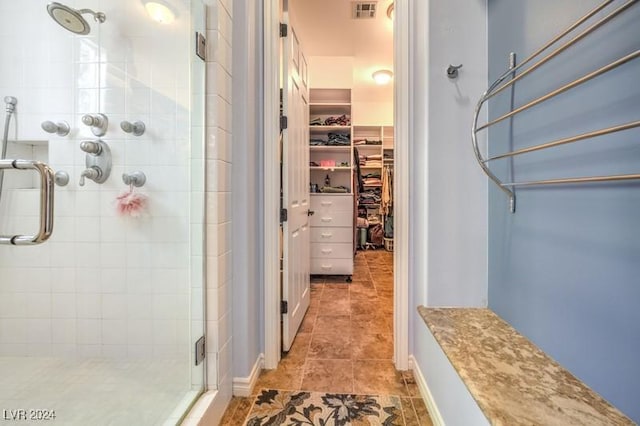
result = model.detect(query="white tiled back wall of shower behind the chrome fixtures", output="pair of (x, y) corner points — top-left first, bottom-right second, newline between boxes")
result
(0, 0), (195, 358)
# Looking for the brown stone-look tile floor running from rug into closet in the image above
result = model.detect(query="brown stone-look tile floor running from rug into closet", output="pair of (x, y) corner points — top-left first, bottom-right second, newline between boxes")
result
(222, 250), (432, 426)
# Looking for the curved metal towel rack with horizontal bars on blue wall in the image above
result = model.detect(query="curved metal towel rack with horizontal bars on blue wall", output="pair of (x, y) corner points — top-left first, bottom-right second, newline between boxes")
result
(471, 0), (640, 213)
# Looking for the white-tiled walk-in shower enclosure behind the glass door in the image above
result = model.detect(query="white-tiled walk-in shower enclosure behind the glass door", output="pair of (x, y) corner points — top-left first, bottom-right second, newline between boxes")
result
(0, 0), (205, 426)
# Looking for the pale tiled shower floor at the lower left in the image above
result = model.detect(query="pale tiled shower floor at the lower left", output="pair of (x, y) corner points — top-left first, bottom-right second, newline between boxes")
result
(0, 357), (190, 426)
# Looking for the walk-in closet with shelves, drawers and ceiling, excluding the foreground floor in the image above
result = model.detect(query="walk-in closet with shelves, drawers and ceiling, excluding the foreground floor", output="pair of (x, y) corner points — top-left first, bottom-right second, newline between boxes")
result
(289, 0), (394, 282)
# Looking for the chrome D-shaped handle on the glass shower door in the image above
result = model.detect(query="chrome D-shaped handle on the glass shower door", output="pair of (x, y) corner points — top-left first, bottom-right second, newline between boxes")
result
(0, 160), (55, 246)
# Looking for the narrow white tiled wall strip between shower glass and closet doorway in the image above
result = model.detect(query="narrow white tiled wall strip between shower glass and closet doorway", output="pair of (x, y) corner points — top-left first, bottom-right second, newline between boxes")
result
(205, 0), (233, 399)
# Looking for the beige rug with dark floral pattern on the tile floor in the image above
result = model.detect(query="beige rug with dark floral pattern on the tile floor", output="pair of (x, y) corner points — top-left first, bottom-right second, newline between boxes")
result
(245, 390), (404, 426)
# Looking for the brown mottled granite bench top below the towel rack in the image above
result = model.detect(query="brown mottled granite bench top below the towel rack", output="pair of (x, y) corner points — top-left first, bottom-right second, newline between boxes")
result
(418, 306), (635, 426)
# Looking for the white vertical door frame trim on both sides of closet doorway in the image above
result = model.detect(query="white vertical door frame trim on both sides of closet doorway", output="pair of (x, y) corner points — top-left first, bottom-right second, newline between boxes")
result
(262, 0), (413, 370)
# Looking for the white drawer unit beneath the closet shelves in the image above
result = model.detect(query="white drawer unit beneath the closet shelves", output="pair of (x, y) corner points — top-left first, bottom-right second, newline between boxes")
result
(311, 194), (353, 275)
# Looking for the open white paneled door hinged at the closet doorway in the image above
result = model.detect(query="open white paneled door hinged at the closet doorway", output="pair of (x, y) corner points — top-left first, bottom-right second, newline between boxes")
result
(282, 1), (310, 351)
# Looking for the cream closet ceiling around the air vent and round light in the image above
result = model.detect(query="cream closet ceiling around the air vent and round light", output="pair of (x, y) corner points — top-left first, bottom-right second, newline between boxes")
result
(289, 0), (393, 99)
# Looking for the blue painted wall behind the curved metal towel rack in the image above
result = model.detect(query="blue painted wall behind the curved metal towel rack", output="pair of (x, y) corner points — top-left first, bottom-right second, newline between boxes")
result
(488, 0), (640, 422)
